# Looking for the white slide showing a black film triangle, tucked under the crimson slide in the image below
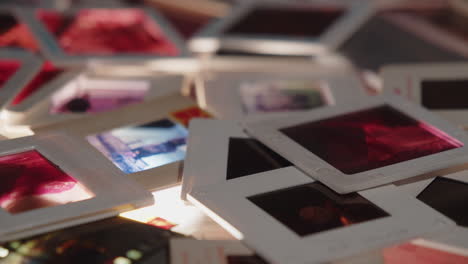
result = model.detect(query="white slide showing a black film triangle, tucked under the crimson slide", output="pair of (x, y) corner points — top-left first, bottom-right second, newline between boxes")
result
(181, 119), (292, 199)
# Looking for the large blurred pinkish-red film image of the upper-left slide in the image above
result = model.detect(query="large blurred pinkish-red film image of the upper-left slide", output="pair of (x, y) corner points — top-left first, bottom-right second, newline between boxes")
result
(38, 9), (179, 56)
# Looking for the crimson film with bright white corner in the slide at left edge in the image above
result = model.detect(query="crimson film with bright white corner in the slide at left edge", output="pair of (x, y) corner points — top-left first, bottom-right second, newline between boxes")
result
(0, 150), (93, 213)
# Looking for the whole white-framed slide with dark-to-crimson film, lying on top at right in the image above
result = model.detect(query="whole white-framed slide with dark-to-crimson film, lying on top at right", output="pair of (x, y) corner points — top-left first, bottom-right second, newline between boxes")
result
(245, 96), (468, 193)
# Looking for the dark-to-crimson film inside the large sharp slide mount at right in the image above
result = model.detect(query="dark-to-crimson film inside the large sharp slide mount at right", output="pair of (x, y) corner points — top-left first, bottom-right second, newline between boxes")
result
(280, 105), (463, 174)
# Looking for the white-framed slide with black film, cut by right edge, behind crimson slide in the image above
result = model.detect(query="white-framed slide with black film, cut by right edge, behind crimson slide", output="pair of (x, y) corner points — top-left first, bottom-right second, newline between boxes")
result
(381, 63), (468, 128)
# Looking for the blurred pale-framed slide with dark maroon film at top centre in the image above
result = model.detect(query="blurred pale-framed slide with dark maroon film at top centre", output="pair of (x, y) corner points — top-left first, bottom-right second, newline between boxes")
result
(189, 1), (372, 55)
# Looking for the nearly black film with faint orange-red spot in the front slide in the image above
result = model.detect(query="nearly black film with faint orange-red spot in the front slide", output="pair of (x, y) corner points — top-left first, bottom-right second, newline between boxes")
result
(247, 182), (390, 237)
